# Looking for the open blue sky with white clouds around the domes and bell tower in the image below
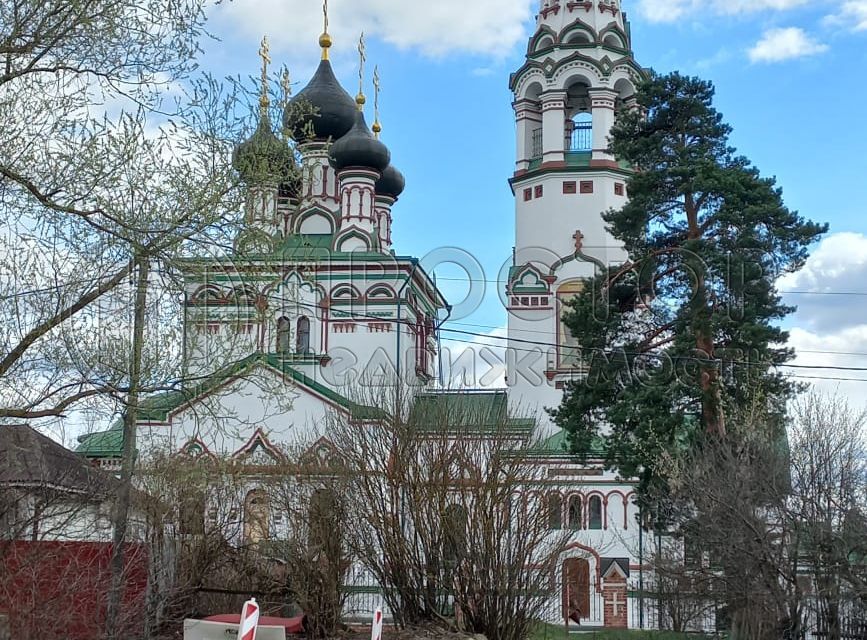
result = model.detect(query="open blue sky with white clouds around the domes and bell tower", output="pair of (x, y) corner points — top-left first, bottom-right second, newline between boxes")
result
(202, 0), (867, 402)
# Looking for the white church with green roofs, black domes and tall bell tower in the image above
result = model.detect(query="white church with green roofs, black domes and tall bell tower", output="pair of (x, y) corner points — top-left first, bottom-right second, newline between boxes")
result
(79, 0), (656, 627)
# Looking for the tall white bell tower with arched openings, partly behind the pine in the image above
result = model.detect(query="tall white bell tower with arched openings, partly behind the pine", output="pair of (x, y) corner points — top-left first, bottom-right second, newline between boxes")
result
(505, 0), (645, 426)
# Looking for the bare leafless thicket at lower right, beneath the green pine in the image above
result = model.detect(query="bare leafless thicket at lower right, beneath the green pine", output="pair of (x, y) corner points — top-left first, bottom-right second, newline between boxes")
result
(648, 392), (867, 640)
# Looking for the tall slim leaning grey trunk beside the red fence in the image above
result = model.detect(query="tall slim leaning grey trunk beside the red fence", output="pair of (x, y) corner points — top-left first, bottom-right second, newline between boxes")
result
(105, 254), (150, 640)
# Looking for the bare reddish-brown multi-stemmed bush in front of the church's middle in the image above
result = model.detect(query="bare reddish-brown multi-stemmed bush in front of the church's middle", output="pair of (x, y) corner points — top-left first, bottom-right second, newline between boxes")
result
(326, 384), (566, 640)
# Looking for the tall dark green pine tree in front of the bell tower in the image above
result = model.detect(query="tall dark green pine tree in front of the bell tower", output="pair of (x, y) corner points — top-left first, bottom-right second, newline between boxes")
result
(552, 73), (827, 496)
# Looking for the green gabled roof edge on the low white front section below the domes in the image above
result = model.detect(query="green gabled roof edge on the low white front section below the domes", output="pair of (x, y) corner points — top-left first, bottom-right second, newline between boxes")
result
(76, 352), (388, 458)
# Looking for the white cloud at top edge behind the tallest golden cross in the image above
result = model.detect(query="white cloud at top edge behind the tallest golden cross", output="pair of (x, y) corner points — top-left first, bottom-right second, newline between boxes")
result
(212, 0), (535, 57)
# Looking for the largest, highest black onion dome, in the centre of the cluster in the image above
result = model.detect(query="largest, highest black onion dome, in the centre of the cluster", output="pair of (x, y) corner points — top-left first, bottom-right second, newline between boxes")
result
(283, 60), (356, 141)
